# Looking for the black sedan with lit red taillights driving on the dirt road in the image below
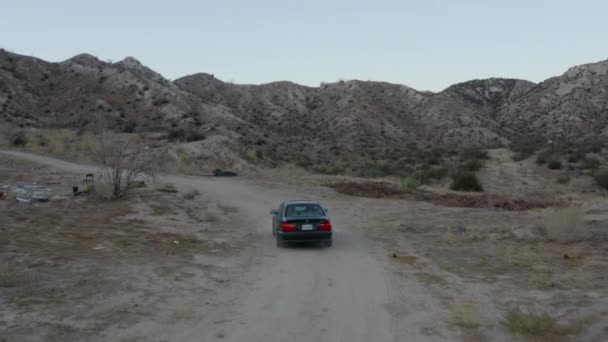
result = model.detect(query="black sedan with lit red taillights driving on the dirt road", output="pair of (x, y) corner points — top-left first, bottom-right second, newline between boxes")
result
(270, 201), (332, 247)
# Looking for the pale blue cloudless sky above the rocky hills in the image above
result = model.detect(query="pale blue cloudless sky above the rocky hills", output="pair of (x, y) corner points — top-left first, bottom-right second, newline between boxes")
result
(0, 0), (608, 91)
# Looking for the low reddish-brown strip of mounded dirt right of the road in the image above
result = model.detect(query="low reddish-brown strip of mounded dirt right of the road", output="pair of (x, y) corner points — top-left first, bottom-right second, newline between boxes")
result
(326, 182), (558, 211)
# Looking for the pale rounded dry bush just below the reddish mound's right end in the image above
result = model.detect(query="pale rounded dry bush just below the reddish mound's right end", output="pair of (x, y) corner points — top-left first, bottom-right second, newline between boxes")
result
(543, 206), (591, 242)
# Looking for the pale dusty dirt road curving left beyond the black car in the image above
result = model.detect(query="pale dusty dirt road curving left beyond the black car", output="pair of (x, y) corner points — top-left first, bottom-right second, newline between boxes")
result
(2, 152), (404, 341)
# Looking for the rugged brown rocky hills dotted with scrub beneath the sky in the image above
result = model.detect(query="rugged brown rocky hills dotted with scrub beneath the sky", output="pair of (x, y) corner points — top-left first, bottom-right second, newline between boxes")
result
(0, 50), (608, 166)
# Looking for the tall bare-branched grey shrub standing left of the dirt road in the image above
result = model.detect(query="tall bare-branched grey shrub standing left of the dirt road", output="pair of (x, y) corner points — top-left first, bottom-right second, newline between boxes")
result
(95, 131), (163, 199)
